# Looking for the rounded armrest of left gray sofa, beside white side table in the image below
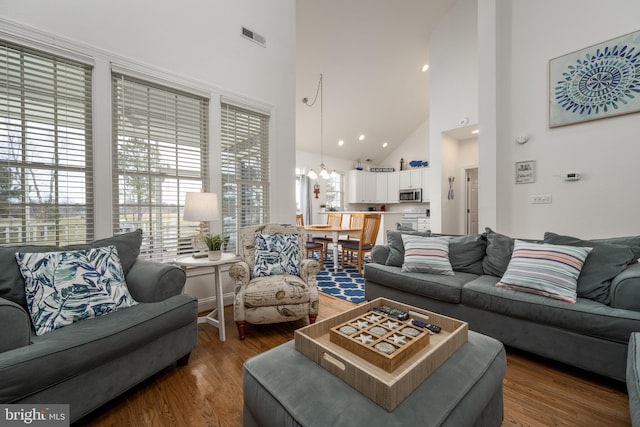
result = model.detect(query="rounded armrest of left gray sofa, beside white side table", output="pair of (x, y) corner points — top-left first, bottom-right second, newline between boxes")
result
(126, 258), (187, 302)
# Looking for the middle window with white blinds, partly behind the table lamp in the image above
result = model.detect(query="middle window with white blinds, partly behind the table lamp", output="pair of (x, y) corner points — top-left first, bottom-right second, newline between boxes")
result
(112, 72), (209, 261)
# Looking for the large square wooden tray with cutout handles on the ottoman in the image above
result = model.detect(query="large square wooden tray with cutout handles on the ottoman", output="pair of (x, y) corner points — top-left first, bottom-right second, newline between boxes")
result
(295, 298), (469, 411)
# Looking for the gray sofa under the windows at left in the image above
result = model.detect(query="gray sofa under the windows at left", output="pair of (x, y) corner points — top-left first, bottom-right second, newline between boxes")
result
(0, 231), (198, 422)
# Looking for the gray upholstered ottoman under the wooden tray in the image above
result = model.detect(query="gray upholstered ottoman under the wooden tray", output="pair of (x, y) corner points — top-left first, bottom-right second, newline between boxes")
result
(243, 331), (507, 427)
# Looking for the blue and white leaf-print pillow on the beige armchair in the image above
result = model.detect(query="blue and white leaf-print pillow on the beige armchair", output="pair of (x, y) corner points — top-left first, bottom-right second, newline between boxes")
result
(253, 234), (300, 277)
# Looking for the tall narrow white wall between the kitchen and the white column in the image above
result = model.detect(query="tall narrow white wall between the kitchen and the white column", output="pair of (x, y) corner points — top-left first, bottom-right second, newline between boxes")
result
(429, 0), (478, 232)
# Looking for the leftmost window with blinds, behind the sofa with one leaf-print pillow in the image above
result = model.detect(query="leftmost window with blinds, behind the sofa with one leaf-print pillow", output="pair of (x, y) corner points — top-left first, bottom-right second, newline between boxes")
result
(0, 41), (94, 245)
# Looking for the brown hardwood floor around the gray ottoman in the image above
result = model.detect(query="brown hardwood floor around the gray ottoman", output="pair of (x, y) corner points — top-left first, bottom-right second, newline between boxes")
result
(75, 294), (631, 427)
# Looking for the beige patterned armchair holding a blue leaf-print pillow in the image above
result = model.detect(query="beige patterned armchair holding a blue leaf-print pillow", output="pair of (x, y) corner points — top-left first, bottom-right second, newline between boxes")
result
(229, 224), (320, 339)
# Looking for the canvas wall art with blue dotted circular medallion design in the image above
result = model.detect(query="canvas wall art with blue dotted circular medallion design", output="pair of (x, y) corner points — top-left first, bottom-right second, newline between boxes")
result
(549, 31), (640, 127)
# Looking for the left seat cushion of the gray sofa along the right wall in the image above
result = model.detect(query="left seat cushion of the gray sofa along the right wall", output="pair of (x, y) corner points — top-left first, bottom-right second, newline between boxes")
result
(364, 263), (478, 304)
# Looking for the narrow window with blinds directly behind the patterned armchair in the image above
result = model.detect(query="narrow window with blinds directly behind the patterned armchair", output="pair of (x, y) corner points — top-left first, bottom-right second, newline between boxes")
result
(221, 103), (269, 252)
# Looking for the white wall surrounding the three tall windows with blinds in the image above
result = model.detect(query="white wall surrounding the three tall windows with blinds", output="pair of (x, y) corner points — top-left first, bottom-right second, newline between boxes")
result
(0, 0), (295, 235)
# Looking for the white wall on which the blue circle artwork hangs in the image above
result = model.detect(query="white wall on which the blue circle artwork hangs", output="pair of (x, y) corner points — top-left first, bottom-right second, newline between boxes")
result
(479, 0), (640, 238)
